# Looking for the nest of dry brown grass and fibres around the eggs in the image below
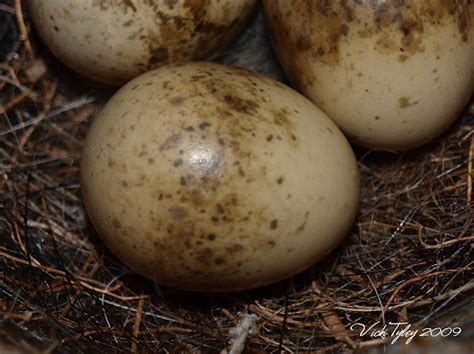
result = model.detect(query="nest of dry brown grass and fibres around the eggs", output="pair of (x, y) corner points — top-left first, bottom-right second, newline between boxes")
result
(0, 1), (474, 353)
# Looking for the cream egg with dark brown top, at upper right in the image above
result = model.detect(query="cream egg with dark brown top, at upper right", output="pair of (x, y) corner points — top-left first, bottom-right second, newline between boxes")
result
(264, 0), (474, 150)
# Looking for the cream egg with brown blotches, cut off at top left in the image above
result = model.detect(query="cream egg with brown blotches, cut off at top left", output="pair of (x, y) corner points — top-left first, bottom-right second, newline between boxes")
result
(29, 0), (256, 84)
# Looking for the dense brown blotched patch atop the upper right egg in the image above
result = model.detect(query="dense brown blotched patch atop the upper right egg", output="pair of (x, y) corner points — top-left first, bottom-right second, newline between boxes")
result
(264, 0), (472, 71)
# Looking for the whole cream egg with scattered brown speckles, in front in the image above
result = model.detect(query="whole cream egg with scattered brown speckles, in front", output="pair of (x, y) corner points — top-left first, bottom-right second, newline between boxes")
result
(81, 62), (359, 291)
